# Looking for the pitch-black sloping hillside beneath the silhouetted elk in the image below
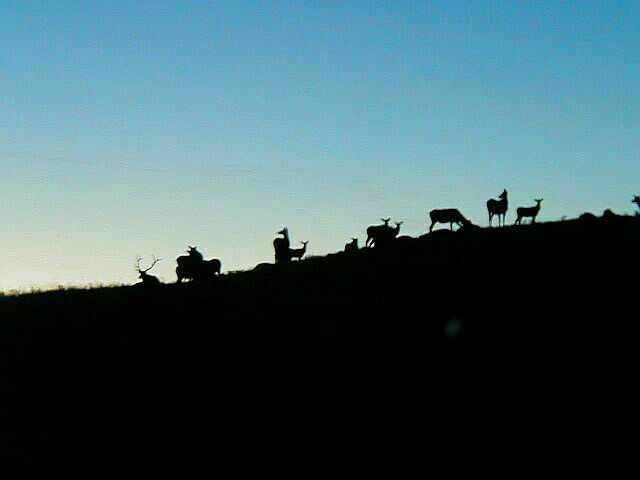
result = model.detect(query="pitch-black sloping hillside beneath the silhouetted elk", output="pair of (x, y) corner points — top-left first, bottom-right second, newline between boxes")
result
(0, 217), (640, 478)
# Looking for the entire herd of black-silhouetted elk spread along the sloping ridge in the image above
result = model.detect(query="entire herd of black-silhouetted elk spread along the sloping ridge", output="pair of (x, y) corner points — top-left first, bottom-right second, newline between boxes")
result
(136, 189), (640, 286)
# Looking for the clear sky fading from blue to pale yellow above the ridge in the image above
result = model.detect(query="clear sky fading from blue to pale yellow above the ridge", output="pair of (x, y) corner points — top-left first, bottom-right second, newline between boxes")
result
(0, 0), (640, 290)
